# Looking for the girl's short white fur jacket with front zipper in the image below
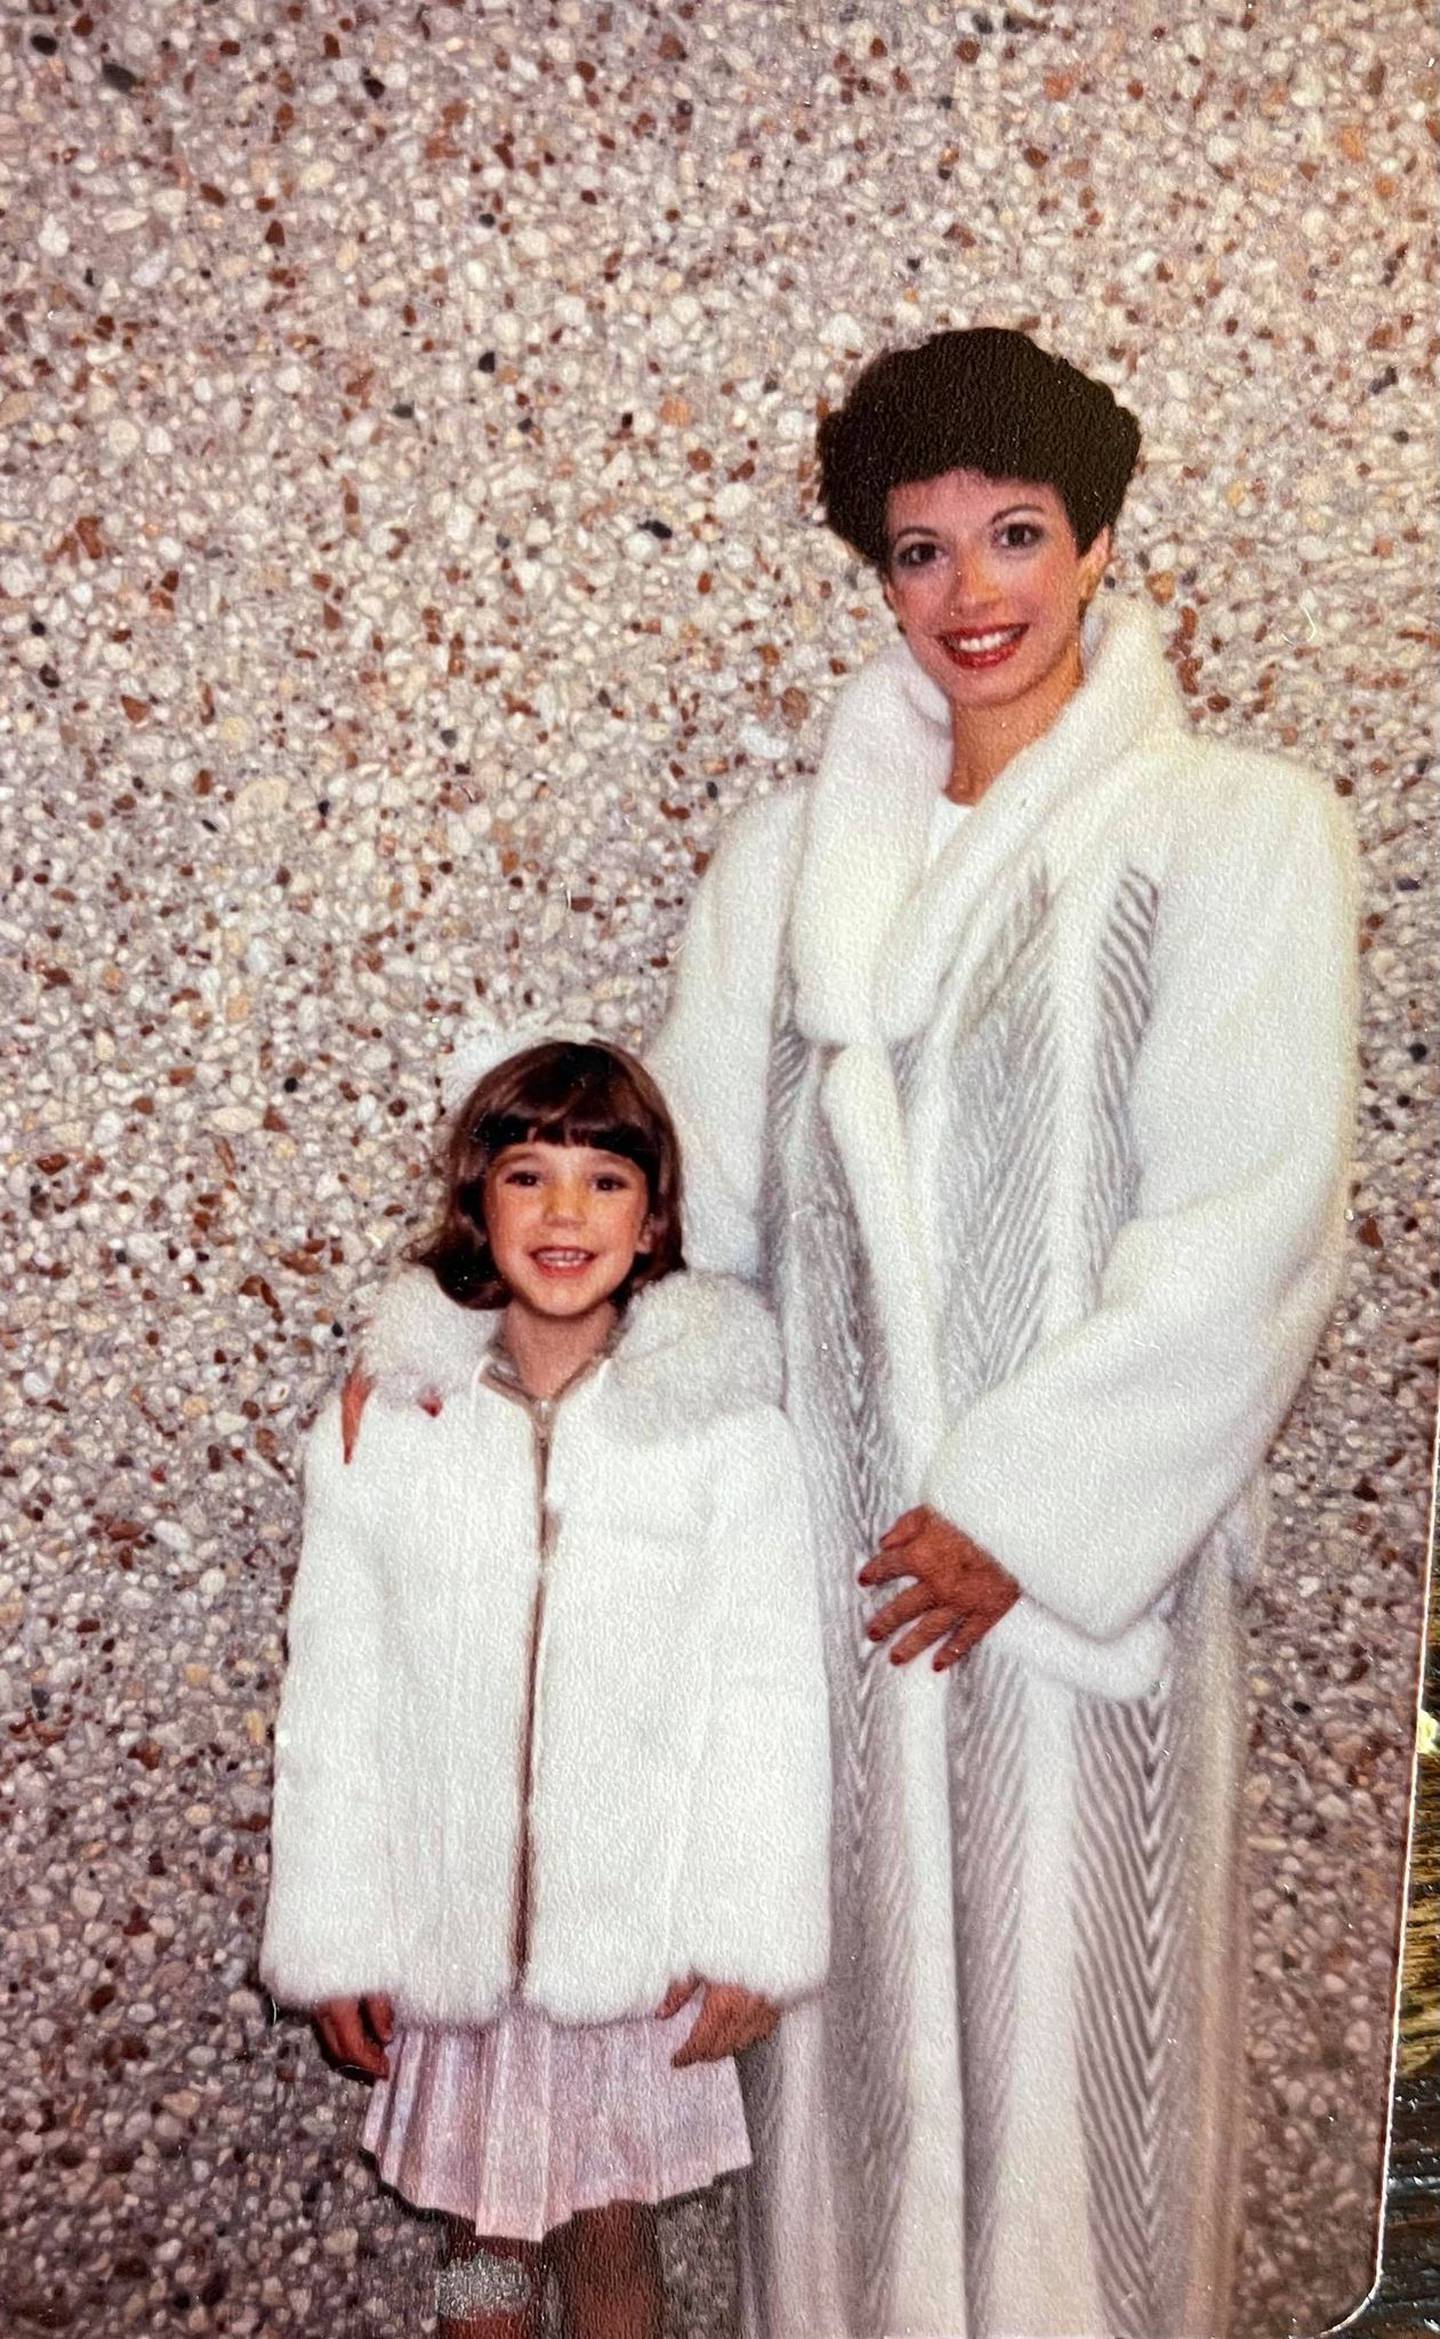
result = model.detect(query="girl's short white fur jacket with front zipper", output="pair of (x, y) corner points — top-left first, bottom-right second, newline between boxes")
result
(259, 1268), (830, 2026)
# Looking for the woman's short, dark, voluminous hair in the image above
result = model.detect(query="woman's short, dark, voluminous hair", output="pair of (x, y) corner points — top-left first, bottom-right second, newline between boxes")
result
(818, 325), (1141, 568)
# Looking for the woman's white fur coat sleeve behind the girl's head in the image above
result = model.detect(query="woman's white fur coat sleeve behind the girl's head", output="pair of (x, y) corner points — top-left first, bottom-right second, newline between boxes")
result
(648, 793), (804, 1279)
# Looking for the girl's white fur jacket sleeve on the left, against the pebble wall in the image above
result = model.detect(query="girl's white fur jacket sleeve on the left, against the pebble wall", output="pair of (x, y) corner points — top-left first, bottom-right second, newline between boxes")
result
(259, 1399), (395, 2007)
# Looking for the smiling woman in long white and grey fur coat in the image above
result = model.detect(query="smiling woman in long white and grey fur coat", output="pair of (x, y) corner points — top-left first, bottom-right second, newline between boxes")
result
(652, 330), (1354, 2339)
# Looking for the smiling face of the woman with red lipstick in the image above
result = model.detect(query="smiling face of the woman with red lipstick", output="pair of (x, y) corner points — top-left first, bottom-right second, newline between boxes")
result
(884, 470), (1110, 737)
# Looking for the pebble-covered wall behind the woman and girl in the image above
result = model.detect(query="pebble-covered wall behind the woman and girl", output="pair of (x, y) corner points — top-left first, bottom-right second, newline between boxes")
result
(0, 0), (1440, 2339)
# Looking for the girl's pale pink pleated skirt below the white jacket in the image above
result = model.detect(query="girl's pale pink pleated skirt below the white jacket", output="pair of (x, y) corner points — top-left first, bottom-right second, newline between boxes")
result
(362, 1998), (750, 2241)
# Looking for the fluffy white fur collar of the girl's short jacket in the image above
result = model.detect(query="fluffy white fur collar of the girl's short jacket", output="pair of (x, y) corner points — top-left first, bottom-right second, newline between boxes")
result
(362, 1268), (781, 1438)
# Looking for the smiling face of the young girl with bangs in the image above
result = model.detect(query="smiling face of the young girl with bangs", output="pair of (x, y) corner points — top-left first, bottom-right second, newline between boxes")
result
(484, 1144), (650, 1322)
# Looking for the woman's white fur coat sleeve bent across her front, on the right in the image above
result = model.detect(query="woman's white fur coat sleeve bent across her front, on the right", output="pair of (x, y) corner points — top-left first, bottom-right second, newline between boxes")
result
(926, 753), (1356, 1637)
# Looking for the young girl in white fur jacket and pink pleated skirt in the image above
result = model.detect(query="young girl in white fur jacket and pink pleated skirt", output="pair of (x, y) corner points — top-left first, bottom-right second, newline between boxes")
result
(262, 1039), (830, 2339)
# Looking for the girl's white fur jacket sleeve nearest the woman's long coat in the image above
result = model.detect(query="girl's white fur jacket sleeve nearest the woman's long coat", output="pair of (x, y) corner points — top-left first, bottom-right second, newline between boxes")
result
(676, 1408), (830, 2002)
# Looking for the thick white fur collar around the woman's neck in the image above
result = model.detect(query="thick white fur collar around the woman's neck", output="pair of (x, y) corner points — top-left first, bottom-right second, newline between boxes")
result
(790, 601), (1185, 1046)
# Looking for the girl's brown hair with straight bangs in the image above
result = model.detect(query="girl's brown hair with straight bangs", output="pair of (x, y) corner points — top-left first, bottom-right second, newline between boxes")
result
(414, 1041), (685, 1308)
